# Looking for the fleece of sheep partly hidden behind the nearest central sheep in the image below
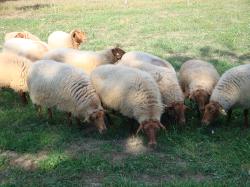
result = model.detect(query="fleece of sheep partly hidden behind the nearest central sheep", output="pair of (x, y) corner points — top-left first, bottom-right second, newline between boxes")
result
(118, 57), (184, 106)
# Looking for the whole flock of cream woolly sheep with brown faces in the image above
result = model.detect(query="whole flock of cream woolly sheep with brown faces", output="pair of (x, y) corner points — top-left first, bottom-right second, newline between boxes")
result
(0, 29), (250, 146)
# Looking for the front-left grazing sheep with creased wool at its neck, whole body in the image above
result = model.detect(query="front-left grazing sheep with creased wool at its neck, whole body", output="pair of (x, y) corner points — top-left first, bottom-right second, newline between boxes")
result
(27, 60), (106, 133)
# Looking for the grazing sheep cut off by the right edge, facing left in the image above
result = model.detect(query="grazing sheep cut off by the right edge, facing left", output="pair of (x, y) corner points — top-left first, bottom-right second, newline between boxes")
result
(202, 64), (250, 127)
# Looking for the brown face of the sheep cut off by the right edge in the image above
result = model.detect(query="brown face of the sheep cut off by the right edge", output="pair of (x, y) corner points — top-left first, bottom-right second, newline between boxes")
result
(202, 101), (221, 125)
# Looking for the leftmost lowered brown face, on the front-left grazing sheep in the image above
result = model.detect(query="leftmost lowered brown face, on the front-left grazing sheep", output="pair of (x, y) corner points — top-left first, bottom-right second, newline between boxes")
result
(90, 111), (107, 134)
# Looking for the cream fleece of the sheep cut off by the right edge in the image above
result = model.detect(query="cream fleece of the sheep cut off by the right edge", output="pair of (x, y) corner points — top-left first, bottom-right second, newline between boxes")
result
(210, 64), (250, 111)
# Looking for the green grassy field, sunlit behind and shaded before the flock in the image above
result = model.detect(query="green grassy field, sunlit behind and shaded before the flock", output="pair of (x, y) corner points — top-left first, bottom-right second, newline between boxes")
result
(0, 0), (250, 187)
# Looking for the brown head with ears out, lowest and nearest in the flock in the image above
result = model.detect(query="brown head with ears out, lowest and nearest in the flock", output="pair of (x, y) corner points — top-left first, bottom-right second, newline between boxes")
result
(136, 120), (165, 147)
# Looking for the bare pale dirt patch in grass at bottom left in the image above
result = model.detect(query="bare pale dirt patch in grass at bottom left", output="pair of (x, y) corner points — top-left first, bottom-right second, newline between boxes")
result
(0, 150), (47, 170)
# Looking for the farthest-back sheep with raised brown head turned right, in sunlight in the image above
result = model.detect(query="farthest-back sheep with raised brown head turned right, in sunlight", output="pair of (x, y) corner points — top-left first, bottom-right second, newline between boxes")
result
(48, 29), (87, 49)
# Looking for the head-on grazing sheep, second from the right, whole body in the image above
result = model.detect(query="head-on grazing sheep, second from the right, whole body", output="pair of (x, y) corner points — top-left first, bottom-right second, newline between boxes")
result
(179, 60), (220, 114)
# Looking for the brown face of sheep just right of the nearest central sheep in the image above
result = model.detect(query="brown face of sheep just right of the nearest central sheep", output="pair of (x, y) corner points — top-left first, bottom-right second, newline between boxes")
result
(166, 102), (186, 125)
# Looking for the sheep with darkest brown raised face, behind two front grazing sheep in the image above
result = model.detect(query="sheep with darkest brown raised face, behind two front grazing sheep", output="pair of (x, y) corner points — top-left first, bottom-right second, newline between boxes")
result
(43, 48), (125, 75)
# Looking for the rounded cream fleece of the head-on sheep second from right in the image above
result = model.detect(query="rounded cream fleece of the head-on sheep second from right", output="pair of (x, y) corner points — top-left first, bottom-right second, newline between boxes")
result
(179, 60), (220, 95)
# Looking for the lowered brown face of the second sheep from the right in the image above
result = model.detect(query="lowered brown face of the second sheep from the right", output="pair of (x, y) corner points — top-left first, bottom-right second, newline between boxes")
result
(189, 90), (210, 114)
